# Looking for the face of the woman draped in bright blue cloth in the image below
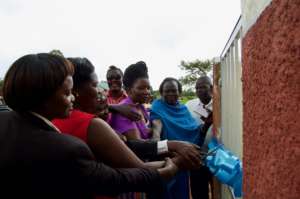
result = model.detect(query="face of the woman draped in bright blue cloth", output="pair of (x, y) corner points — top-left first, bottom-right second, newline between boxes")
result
(161, 81), (180, 105)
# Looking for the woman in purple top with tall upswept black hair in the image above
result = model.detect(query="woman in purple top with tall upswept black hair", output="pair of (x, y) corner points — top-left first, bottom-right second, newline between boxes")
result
(111, 61), (152, 140)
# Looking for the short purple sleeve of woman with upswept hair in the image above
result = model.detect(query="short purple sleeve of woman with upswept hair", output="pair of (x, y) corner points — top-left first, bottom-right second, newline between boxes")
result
(112, 114), (137, 134)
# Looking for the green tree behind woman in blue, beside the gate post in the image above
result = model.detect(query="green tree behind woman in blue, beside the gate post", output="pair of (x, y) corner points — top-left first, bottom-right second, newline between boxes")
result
(179, 59), (213, 88)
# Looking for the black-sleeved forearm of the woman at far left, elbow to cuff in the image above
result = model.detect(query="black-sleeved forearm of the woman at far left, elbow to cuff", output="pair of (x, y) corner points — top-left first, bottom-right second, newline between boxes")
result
(76, 156), (162, 196)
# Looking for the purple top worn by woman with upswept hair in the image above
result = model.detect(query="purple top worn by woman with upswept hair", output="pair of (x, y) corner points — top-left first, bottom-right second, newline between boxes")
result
(110, 97), (150, 139)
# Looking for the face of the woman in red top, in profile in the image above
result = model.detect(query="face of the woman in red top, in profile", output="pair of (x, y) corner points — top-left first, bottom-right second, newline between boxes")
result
(74, 73), (101, 113)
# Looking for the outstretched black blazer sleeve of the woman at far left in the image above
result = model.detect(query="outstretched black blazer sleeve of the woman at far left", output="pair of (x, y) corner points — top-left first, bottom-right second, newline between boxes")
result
(69, 141), (163, 196)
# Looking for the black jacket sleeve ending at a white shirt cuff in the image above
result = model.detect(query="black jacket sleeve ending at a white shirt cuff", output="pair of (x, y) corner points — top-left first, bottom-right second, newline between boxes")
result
(126, 140), (158, 159)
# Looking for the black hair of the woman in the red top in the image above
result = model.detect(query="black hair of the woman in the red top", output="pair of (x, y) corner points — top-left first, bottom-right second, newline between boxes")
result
(67, 57), (95, 89)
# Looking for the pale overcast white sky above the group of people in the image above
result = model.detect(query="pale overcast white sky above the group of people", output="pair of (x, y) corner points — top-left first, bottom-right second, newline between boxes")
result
(0, 0), (241, 89)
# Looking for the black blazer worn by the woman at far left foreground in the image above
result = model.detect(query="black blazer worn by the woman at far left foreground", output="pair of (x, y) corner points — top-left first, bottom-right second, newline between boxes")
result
(0, 111), (162, 199)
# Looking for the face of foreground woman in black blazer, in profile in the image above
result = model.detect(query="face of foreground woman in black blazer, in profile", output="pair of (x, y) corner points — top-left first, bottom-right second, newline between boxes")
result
(43, 76), (74, 120)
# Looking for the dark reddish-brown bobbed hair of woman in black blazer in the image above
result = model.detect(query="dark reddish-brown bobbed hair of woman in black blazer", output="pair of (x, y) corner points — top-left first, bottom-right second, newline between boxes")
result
(3, 53), (74, 112)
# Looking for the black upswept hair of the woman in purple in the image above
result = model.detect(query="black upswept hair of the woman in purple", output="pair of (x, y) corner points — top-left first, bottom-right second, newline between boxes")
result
(123, 61), (149, 90)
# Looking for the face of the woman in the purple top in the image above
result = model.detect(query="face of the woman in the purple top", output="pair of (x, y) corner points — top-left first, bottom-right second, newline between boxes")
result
(128, 78), (150, 104)
